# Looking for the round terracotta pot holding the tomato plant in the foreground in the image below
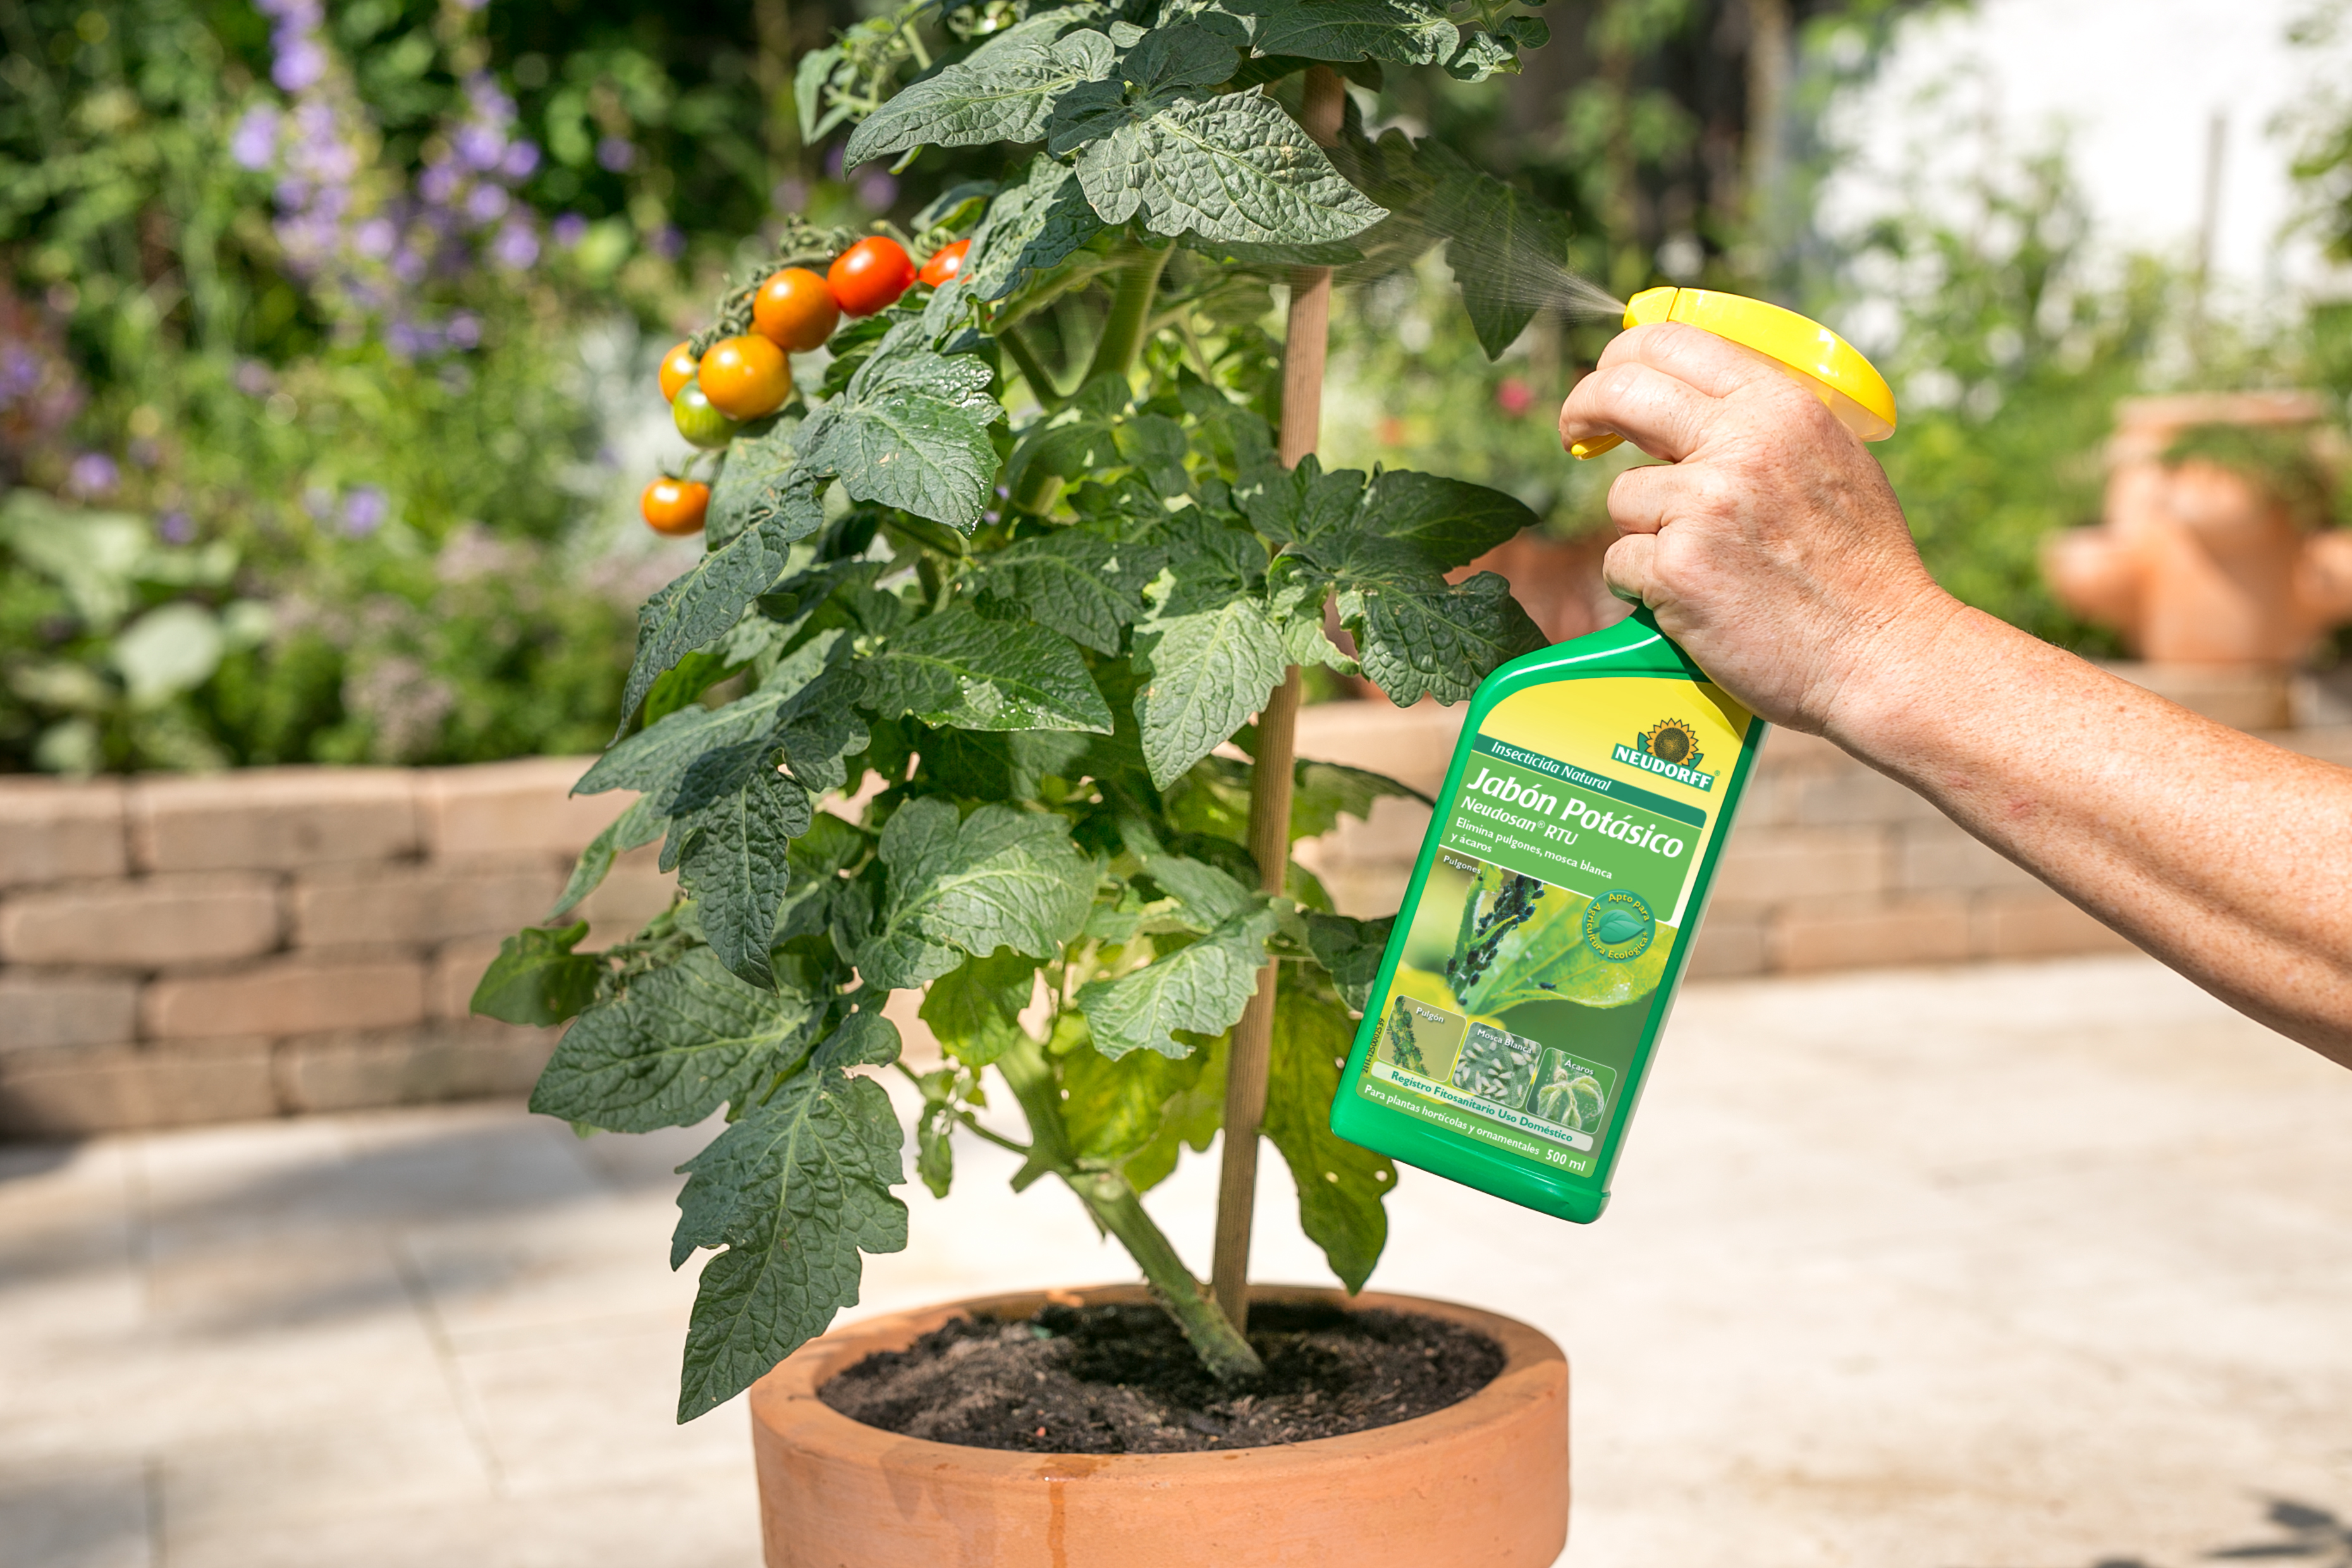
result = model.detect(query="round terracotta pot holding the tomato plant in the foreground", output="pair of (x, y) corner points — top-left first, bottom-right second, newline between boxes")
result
(750, 1286), (1569, 1568)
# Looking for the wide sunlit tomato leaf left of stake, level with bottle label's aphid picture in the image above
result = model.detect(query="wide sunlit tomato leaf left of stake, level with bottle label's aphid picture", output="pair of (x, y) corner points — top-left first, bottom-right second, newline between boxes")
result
(856, 797), (1094, 989)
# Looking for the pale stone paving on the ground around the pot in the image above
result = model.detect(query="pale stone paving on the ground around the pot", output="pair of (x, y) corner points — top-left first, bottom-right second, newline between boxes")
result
(0, 959), (2352, 1568)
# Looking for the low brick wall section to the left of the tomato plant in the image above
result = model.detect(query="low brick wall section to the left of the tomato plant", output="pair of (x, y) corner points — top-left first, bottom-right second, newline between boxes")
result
(0, 757), (670, 1136)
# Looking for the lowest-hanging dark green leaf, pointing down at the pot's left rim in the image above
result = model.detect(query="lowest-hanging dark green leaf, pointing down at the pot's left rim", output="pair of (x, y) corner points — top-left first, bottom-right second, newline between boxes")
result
(670, 1014), (905, 1422)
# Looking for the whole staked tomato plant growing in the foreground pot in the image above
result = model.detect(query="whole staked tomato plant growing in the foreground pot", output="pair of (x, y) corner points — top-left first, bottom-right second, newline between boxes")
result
(477, 0), (1567, 1420)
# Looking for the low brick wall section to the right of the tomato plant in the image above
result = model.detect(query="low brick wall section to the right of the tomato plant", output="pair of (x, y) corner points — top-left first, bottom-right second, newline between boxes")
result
(1298, 703), (2352, 976)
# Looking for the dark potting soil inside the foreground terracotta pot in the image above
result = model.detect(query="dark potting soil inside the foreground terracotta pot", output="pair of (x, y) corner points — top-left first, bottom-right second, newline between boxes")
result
(821, 1305), (1503, 1453)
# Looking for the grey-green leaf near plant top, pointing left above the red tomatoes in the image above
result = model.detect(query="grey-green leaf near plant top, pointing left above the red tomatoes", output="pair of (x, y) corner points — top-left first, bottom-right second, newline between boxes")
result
(842, 28), (1117, 167)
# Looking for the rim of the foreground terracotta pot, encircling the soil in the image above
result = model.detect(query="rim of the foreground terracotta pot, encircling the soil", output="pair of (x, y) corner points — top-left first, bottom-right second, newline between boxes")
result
(750, 1283), (1569, 1486)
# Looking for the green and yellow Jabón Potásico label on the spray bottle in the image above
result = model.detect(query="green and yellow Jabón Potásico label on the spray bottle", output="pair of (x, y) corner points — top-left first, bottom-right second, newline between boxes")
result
(1357, 677), (1748, 1175)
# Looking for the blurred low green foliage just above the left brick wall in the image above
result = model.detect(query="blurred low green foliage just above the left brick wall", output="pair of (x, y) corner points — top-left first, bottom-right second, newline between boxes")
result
(0, 489), (633, 773)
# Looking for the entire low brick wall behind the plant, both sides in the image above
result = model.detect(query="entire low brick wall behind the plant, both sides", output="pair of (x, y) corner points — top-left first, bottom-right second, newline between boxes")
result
(0, 703), (2352, 1136)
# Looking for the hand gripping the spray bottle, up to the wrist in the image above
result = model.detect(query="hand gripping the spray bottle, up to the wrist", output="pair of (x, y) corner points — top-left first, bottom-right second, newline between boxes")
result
(1559, 322), (1961, 733)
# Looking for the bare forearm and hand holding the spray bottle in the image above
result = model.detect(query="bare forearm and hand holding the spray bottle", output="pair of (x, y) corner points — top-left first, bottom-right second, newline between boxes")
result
(1559, 324), (2352, 1065)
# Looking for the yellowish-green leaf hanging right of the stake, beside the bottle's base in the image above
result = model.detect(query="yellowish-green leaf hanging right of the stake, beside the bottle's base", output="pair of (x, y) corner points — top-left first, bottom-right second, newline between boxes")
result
(1265, 976), (1397, 1295)
